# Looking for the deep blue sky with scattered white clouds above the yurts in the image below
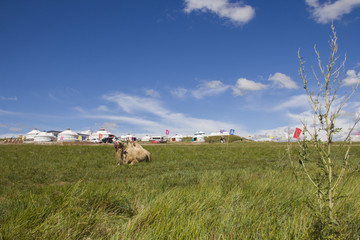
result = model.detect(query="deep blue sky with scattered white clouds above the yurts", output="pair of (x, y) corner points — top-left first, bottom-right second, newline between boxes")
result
(0, 0), (360, 140)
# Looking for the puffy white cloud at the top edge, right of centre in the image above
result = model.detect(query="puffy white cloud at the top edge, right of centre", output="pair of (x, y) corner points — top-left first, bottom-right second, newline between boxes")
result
(185, 0), (255, 24)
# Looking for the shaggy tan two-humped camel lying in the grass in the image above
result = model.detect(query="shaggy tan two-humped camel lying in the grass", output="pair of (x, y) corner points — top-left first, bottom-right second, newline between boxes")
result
(114, 140), (151, 165)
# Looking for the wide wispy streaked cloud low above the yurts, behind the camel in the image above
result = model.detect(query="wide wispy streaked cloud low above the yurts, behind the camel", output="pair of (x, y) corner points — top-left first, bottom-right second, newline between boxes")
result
(90, 92), (245, 135)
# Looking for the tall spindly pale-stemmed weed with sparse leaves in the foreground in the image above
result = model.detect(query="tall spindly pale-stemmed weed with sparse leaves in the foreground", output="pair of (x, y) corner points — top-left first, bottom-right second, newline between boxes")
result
(296, 25), (360, 239)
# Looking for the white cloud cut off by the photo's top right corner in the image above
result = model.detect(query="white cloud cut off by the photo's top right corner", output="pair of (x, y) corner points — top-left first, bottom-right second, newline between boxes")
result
(305, 0), (360, 23)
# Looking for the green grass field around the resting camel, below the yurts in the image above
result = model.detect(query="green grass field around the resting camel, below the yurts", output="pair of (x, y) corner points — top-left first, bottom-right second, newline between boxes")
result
(0, 142), (360, 239)
